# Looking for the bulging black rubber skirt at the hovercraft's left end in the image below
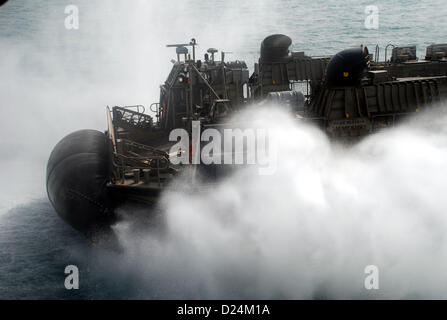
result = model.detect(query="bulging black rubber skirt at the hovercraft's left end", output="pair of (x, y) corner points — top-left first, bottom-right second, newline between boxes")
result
(47, 130), (113, 233)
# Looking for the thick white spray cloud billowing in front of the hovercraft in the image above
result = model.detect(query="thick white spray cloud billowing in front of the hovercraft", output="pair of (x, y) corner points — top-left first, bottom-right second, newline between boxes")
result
(111, 109), (447, 299)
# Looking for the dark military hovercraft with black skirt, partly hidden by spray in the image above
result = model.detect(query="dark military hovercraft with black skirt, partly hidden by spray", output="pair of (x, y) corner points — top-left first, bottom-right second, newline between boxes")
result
(47, 34), (447, 235)
